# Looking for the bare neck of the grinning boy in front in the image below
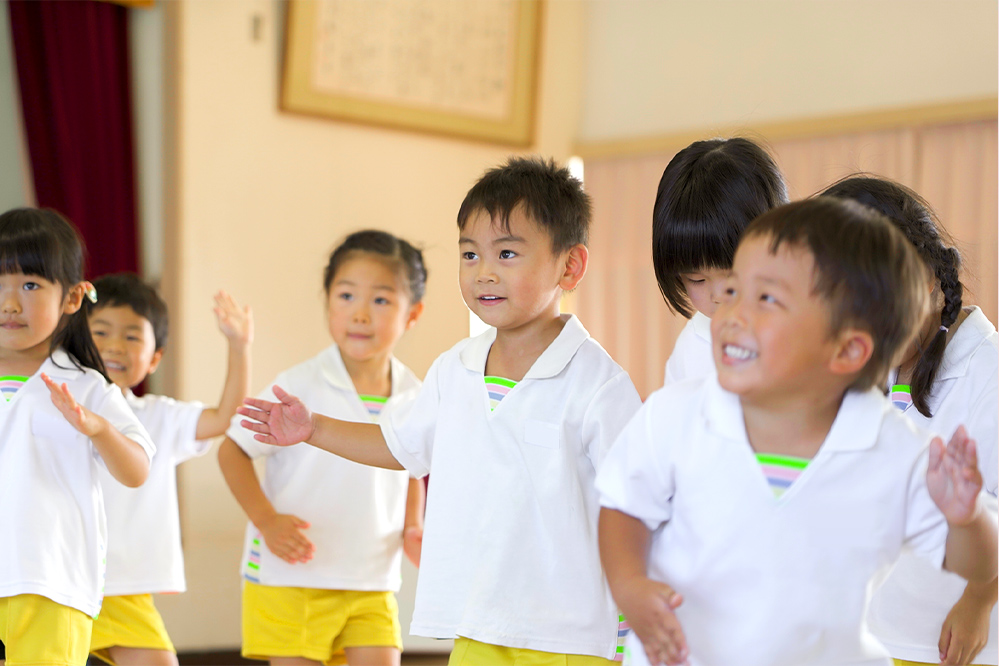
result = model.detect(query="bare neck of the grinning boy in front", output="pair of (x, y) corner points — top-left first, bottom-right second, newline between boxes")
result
(741, 389), (845, 459)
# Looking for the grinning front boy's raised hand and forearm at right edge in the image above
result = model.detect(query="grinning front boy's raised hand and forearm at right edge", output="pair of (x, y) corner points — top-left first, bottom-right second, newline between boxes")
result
(926, 426), (999, 583)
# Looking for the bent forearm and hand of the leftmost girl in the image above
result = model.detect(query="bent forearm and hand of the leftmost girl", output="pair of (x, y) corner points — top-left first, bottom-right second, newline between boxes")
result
(42, 373), (149, 488)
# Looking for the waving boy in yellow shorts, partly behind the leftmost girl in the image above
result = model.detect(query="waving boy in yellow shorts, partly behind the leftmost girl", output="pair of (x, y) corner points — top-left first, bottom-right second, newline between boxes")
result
(90, 273), (253, 666)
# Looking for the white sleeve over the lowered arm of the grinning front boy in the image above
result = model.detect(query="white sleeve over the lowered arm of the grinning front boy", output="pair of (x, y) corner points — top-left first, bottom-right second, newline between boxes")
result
(597, 394), (675, 530)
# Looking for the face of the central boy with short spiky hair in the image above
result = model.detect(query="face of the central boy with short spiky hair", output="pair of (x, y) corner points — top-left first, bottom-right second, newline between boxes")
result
(458, 206), (585, 331)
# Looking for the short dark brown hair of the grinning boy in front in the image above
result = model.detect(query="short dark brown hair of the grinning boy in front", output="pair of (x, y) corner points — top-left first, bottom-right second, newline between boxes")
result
(743, 196), (927, 390)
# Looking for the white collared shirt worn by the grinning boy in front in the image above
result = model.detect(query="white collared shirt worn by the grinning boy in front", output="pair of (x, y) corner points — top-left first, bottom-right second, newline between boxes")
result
(597, 376), (947, 666)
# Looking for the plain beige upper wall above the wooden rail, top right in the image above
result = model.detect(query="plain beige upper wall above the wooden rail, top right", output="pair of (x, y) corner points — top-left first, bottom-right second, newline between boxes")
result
(578, 0), (999, 142)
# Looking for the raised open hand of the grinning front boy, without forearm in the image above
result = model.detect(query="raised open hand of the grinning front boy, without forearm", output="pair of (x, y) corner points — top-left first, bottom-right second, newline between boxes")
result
(926, 426), (982, 525)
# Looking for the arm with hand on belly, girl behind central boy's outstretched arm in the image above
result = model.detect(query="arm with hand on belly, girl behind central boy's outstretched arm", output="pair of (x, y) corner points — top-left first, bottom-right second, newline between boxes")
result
(219, 437), (316, 564)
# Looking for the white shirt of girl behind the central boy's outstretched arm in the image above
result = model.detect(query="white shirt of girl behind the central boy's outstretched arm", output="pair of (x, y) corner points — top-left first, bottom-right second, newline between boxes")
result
(226, 345), (420, 591)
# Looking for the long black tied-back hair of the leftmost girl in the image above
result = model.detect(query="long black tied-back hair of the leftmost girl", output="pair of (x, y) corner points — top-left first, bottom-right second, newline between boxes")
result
(0, 208), (111, 382)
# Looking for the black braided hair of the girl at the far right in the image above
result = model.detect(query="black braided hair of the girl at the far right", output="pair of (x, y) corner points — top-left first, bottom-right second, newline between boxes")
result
(823, 176), (964, 418)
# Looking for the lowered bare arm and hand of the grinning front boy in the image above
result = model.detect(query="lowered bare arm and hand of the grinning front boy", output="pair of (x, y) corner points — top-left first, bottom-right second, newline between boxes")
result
(599, 508), (688, 666)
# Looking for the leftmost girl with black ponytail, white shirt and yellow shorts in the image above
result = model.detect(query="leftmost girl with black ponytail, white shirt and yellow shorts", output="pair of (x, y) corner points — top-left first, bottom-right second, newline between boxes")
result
(0, 208), (155, 664)
